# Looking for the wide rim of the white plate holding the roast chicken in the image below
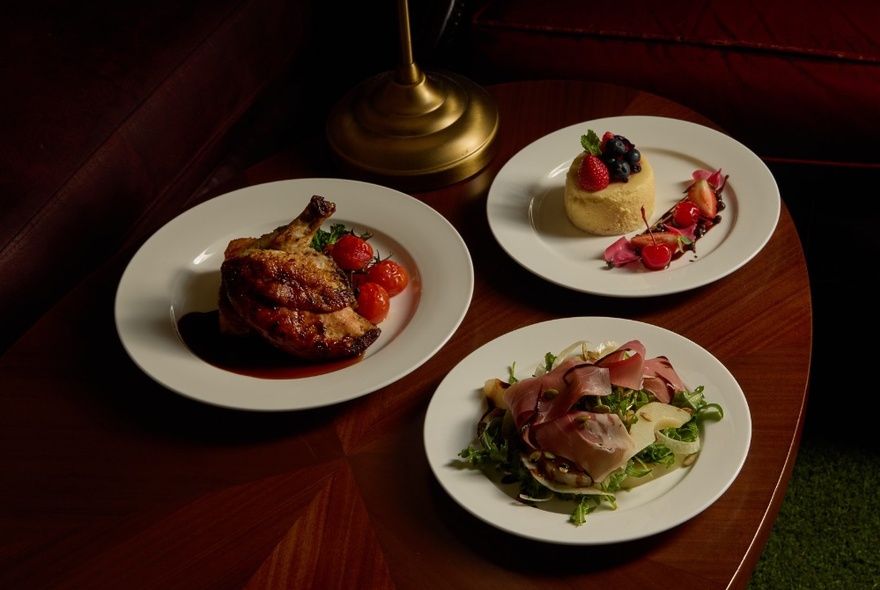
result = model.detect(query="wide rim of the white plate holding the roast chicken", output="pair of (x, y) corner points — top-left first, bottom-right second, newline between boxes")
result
(114, 177), (474, 411)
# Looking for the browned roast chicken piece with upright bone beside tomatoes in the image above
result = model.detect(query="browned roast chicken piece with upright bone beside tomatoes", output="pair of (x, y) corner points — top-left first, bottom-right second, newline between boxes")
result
(219, 195), (380, 361)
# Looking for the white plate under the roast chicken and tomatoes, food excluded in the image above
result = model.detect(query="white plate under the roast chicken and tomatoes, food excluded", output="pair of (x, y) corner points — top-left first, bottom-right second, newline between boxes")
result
(115, 178), (474, 411)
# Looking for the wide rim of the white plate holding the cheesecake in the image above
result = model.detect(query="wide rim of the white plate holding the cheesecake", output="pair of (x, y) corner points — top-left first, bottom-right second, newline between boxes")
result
(486, 115), (782, 298)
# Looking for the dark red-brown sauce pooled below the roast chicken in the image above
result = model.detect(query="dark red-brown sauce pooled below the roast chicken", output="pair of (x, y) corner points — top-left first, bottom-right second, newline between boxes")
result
(177, 310), (363, 379)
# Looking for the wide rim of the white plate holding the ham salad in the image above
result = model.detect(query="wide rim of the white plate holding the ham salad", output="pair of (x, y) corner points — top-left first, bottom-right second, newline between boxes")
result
(423, 316), (752, 545)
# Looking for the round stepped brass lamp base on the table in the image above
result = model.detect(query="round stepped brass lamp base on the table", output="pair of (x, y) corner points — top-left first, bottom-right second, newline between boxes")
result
(327, 67), (499, 191)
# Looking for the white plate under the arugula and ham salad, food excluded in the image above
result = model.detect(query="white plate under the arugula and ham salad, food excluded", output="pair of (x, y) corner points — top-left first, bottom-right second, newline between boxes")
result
(424, 317), (752, 545)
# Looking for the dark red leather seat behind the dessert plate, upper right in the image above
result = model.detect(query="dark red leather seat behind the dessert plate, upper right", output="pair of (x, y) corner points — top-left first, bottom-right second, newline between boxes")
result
(454, 0), (880, 167)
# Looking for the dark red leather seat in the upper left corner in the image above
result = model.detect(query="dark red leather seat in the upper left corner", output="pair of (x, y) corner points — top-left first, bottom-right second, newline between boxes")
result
(0, 0), (308, 350)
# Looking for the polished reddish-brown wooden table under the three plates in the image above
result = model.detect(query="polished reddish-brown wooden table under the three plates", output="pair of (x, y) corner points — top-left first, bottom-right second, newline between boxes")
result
(0, 82), (812, 590)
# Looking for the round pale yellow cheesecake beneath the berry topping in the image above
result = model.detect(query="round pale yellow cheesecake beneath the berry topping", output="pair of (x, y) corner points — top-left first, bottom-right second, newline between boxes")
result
(565, 152), (654, 236)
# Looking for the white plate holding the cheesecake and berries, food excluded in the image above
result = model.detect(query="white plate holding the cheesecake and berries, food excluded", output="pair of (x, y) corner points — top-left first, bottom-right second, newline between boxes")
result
(486, 117), (781, 297)
